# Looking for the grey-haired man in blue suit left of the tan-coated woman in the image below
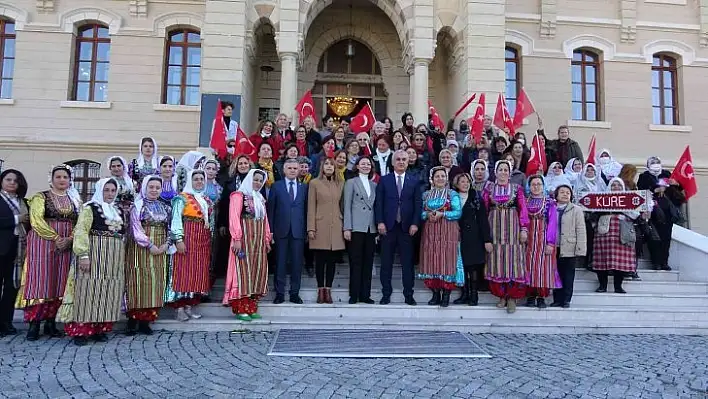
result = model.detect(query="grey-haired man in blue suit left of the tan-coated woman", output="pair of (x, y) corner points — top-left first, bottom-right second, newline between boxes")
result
(268, 159), (307, 304)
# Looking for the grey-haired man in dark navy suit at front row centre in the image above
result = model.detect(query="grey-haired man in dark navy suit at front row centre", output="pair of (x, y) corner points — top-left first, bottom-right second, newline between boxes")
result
(374, 150), (423, 305)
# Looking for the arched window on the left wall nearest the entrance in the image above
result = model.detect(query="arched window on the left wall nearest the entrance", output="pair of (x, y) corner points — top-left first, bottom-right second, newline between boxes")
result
(162, 29), (202, 105)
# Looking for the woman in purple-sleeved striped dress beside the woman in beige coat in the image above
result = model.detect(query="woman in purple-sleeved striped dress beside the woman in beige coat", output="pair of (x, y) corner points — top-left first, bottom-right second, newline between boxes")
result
(526, 175), (561, 309)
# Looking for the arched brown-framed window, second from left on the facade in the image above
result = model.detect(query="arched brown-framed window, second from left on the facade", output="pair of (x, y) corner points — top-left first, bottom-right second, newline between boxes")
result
(71, 24), (111, 101)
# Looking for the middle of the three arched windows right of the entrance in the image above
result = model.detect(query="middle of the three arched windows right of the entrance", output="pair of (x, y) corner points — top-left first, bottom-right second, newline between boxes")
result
(571, 50), (601, 121)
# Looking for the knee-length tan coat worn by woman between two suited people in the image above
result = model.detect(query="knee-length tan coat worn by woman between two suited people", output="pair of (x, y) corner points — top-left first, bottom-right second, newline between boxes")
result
(307, 179), (344, 251)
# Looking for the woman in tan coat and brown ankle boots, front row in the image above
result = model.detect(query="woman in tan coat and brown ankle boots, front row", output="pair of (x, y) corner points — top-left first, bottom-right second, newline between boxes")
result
(307, 158), (344, 303)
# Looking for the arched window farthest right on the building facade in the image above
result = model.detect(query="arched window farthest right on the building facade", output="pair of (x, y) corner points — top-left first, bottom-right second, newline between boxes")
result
(651, 54), (679, 125)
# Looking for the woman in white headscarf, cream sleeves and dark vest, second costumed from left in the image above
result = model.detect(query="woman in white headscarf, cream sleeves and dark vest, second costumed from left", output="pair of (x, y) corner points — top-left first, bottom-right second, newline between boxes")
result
(59, 178), (125, 346)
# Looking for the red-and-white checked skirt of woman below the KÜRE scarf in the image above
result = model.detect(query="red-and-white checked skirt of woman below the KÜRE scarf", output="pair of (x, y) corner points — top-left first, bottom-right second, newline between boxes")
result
(592, 216), (637, 273)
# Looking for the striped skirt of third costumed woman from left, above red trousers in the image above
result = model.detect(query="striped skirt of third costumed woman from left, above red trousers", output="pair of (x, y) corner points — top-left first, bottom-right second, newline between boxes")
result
(125, 223), (168, 310)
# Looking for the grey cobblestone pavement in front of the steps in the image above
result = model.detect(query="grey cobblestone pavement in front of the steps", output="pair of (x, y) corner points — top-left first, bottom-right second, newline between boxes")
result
(0, 332), (708, 399)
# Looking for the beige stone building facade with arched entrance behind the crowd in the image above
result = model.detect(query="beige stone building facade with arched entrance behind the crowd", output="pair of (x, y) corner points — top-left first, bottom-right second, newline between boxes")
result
(0, 0), (708, 233)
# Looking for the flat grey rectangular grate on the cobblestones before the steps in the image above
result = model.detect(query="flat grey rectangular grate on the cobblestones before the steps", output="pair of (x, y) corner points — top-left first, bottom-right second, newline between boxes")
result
(268, 330), (491, 358)
